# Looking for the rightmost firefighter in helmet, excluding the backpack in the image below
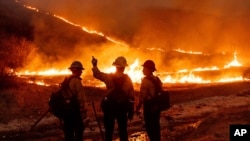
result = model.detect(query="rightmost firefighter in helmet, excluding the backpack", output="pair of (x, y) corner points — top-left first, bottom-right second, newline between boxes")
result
(136, 60), (162, 141)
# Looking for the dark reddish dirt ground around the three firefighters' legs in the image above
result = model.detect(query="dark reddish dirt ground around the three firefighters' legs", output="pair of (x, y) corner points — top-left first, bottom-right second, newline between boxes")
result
(0, 82), (250, 141)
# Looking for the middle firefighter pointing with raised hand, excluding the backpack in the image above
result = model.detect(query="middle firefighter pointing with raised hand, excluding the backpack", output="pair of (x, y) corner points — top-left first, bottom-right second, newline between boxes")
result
(92, 56), (134, 141)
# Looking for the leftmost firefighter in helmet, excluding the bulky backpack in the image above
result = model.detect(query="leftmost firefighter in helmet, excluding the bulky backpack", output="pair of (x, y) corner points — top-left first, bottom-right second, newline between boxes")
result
(62, 61), (87, 141)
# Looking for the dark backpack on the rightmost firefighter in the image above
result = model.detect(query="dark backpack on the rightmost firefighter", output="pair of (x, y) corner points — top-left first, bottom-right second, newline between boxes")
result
(146, 77), (170, 111)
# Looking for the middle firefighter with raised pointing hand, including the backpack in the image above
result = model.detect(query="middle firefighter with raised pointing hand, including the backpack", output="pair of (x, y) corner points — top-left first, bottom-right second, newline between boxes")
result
(92, 56), (134, 141)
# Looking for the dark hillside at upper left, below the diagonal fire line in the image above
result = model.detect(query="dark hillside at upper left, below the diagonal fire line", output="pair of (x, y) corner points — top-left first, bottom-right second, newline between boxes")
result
(0, 0), (108, 56)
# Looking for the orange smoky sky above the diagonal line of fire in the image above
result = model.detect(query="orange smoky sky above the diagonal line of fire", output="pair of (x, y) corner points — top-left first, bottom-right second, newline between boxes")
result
(22, 0), (250, 69)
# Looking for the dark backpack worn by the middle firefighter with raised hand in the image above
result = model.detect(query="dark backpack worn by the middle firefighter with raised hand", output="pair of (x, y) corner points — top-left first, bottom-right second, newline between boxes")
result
(101, 74), (134, 113)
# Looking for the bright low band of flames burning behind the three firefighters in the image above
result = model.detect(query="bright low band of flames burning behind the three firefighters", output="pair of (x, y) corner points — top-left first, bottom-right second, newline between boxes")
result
(17, 55), (246, 86)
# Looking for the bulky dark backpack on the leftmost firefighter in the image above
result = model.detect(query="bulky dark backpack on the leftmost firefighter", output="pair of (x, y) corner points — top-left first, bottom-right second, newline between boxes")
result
(48, 76), (79, 119)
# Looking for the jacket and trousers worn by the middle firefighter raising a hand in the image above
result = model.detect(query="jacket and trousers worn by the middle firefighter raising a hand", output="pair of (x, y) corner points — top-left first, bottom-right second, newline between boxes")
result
(92, 66), (134, 141)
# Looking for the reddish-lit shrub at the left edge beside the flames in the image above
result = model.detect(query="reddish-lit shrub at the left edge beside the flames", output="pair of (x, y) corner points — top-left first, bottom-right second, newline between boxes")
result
(0, 36), (36, 88)
